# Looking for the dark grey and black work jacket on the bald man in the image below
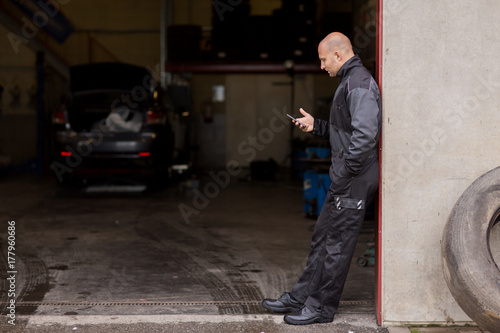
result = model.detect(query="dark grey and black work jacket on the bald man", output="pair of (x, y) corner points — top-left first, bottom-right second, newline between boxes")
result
(312, 55), (382, 177)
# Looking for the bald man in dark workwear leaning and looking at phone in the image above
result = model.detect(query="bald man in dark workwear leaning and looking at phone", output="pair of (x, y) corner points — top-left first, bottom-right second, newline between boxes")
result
(262, 32), (381, 325)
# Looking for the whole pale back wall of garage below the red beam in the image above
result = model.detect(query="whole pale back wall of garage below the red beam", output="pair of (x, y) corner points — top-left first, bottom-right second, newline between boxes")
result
(188, 73), (338, 168)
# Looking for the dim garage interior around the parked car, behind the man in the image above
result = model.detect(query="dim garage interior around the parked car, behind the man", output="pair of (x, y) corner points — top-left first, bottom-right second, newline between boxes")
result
(0, 0), (378, 330)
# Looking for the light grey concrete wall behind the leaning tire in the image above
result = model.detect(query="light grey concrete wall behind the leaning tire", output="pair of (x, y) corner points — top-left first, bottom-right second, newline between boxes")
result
(382, 0), (500, 323)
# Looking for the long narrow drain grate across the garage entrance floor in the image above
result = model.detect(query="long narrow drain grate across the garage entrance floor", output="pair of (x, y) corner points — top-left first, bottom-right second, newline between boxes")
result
(0, 301), (370, 307)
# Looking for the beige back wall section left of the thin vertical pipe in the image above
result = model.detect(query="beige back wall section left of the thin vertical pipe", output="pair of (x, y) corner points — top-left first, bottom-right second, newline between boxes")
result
(226, 74), (291, 166)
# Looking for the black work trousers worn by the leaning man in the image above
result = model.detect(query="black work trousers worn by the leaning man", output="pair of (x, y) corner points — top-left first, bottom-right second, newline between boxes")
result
(291, 157), (379, 318)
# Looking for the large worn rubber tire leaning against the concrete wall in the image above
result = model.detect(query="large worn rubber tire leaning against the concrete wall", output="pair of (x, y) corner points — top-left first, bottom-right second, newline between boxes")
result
(441, 167), (500, 332)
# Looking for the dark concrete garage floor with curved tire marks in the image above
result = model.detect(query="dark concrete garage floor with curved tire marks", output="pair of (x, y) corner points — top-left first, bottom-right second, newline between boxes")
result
(0, 172), (386, 332)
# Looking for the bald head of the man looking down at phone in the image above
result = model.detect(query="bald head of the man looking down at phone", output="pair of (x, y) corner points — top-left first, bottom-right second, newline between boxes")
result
(318, 32), (354, 77)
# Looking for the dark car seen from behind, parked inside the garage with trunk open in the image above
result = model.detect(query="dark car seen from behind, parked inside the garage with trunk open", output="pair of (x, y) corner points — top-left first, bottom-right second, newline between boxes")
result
(51, 63), (174, 183)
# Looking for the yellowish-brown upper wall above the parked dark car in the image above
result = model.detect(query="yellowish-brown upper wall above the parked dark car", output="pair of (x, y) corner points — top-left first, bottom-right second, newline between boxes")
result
(61, 0), (160, 68)
